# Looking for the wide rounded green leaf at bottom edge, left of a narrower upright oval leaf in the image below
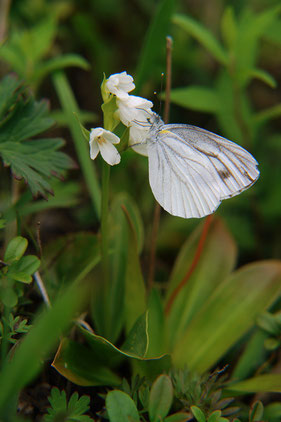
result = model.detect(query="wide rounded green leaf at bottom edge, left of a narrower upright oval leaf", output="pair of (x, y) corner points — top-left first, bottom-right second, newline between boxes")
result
(105, 390), (140, 422)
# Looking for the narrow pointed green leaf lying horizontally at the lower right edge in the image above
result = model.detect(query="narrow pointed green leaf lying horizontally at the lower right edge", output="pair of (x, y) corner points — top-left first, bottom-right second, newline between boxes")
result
(227, 374), (281, 394)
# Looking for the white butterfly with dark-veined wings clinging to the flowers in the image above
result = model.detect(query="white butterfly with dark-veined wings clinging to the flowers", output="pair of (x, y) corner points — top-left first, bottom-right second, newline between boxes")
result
(143, 113), (259, 218)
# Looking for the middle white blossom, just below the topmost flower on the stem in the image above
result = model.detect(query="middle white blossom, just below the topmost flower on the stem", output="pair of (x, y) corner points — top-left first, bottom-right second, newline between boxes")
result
(116, 95), (153, 127)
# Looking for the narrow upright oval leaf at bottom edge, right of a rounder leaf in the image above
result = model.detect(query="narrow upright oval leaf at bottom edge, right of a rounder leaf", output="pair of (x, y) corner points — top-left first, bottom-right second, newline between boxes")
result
(148, 375), (173, 422)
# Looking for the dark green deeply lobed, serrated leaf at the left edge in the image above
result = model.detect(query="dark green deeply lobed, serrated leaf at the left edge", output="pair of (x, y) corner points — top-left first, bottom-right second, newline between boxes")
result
(0, 80), (73, 196)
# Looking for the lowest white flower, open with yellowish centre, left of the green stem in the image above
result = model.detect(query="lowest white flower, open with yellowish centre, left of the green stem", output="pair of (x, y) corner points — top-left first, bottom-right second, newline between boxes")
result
(90, 127), (121, 166)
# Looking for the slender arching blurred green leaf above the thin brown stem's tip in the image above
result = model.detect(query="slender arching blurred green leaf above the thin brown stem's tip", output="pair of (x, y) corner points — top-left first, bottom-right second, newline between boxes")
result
(173, 14), (228, 65)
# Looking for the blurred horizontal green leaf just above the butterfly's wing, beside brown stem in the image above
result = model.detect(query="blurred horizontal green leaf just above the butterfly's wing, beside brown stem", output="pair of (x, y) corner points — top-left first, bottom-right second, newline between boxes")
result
(167, 85), (220, 113)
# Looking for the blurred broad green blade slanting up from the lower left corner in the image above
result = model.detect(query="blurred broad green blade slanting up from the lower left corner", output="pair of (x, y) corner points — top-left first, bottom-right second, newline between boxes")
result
(0, 285), (86, 409)
